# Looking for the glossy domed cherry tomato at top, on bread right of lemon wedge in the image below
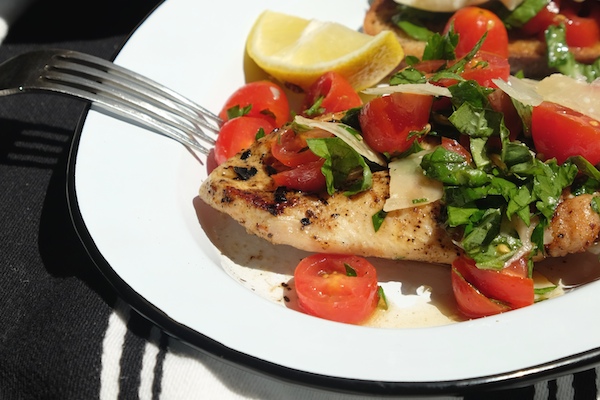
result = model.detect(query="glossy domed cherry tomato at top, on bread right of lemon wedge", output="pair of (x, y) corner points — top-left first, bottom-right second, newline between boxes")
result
(444, 7), (508, 58)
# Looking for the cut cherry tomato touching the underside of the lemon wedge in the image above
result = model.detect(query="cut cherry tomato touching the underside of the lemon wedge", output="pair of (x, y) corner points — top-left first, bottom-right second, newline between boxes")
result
(302, 71), (362, 118)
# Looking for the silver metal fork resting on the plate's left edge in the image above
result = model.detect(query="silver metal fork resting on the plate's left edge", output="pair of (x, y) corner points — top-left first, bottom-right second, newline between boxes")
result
(0, 50), (223, 155)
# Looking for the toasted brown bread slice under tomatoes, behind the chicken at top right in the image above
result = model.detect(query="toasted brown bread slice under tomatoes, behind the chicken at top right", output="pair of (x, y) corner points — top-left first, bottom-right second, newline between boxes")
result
(363, 0), (600, 78)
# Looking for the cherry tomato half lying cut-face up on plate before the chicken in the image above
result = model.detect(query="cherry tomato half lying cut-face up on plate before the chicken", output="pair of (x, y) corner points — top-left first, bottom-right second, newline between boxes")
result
(294, 254), (379, 324)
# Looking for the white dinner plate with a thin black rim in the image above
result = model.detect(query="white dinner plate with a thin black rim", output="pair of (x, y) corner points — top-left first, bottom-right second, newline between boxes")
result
(69, 0), (600, 394)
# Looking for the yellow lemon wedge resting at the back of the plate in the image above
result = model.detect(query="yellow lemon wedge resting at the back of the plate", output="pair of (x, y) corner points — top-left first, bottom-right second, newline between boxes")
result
(246, 10), (404, 91)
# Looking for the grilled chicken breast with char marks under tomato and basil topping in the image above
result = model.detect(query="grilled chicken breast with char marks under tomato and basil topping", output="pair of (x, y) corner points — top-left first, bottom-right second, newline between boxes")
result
(200, 130), (600, 264)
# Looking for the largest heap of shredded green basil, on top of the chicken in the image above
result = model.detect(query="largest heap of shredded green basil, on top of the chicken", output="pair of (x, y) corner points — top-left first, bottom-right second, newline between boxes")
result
(421, 69), (580, 269)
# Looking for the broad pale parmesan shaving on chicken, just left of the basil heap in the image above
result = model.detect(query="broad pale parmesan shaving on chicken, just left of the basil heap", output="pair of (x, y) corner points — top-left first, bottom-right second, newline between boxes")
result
(383, 151), (444, 212)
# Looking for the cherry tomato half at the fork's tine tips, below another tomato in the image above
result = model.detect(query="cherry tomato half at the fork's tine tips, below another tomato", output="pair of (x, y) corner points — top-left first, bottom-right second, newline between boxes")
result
(215, 116), (275, 164)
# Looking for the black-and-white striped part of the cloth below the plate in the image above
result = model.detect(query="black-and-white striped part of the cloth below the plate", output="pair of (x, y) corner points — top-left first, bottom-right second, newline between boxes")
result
(95, 303), (600, 400)
